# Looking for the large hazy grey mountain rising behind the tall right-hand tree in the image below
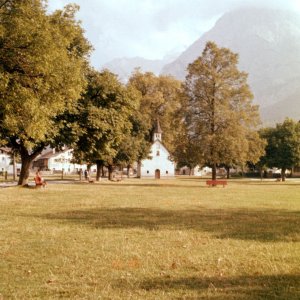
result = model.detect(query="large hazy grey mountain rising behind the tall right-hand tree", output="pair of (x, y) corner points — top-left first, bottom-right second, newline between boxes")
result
(162, 8), (300, 123)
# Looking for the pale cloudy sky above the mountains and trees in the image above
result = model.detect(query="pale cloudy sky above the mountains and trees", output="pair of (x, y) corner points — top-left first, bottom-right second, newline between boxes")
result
(48, 0), (300, 69)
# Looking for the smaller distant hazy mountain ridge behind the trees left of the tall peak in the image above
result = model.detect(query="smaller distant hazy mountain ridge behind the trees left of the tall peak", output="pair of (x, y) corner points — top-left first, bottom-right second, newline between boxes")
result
(103, 56), (174, 82)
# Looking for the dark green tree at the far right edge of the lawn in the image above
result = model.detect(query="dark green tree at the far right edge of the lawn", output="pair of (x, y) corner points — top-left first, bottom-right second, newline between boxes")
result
(260, 119), (300, 181)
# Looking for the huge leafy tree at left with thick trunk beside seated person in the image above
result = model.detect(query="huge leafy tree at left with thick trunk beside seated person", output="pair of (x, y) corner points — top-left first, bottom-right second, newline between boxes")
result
(0, 0), (91, 185)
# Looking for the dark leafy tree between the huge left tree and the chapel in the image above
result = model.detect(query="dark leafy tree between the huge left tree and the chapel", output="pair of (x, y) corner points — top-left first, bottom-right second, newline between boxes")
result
(73, 70), (139, 180)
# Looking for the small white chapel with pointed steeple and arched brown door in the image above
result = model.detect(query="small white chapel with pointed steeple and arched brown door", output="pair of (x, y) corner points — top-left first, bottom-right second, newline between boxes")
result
(137, 120), (175, 179)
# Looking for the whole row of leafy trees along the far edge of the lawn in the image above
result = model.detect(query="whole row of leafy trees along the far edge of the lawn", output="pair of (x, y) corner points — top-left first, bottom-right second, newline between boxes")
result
(0, 0), (300, 185)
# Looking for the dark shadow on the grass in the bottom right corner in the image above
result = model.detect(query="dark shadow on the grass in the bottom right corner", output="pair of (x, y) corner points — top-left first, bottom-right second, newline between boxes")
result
(137, 274), (300, 300)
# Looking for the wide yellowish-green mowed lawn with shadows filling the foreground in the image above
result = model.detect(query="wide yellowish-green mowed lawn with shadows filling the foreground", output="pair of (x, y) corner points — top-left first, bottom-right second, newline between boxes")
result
(0, 178), (300, 299)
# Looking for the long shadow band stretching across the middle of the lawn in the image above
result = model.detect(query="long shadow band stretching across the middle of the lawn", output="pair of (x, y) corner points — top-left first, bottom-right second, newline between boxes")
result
(42, 208), (300, 242)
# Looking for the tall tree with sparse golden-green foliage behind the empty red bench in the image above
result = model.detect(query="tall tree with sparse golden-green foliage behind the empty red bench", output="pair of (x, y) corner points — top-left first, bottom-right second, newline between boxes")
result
(184, 42), (261, 180)
